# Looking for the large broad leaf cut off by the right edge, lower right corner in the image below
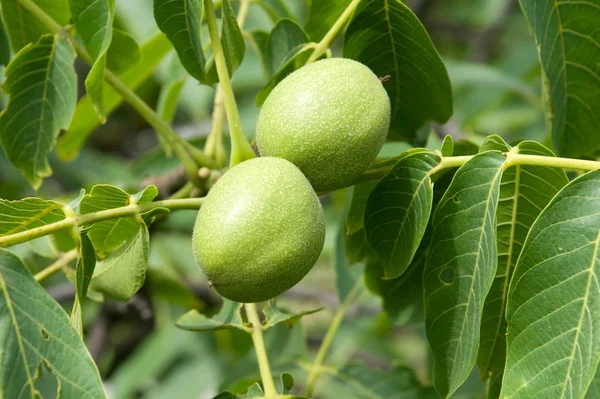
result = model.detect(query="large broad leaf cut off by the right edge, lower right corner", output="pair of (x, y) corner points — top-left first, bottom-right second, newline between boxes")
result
(501, 171), (600, 399)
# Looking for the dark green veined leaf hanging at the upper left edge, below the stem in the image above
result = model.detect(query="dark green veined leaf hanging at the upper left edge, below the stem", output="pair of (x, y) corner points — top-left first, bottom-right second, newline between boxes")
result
(0, 35), (77, 189)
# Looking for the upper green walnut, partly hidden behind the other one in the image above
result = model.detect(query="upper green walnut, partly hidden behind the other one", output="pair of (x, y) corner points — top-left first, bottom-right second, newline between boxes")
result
(256, 58), (390, 192)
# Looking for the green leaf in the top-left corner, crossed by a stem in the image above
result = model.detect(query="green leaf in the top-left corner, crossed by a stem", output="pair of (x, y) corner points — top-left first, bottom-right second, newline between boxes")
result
(0, 0), (71, 53)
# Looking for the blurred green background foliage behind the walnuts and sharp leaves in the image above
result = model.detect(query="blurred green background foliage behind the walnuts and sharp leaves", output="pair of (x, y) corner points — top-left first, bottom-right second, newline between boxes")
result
(0, 0), (550, 399)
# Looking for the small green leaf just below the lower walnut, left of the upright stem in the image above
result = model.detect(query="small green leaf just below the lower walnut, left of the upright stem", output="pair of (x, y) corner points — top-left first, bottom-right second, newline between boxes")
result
(176, 299), (247, 331)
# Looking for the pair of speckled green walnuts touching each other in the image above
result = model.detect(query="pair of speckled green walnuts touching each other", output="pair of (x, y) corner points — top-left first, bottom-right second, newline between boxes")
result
(193, 58), (390, 303)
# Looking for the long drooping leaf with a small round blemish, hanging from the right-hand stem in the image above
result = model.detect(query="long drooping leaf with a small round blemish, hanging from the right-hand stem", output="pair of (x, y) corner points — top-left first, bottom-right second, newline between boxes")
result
(423, 152), (506, 397)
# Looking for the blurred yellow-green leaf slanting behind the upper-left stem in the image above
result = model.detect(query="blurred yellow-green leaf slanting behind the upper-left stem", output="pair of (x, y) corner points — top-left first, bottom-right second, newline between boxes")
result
(56, 33), (172, 161)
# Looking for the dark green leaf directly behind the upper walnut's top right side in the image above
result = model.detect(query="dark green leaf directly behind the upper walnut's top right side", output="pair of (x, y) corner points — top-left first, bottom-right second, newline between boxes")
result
(344, 0), (452, 139)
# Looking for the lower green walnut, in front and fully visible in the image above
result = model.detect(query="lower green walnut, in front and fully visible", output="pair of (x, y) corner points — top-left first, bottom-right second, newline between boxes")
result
(193, 157), (325, 303)
